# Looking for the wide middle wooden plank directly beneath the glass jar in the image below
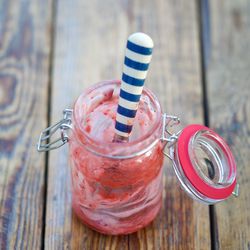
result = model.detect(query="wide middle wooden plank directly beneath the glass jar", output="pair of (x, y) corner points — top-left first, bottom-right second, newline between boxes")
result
(45, 0), (210, 249)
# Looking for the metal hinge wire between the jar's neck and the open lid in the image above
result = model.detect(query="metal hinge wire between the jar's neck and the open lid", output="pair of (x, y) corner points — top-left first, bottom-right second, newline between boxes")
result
(161, 114), (182, 160)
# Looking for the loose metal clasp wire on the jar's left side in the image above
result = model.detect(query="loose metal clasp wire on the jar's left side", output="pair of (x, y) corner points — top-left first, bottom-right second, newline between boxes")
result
(37, 109), (73, 152)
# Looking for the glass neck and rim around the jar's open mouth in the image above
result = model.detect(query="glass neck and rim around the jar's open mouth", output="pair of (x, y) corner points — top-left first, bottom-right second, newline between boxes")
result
(71, 80), (162, 159)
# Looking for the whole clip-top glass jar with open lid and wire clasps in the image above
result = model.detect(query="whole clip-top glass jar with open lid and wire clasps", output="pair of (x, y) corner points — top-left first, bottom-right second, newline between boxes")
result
(38, 80), (238, 234)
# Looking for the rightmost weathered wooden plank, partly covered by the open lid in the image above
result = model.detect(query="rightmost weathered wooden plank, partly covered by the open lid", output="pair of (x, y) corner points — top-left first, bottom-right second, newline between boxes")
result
(203, 0), (250, 250)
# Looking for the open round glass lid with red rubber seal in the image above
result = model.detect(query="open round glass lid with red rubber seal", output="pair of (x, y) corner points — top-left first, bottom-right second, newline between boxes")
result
(170, 124), (236, 203)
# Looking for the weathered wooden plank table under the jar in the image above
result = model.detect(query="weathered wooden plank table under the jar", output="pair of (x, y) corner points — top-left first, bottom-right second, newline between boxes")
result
(0, 0), (250, 250)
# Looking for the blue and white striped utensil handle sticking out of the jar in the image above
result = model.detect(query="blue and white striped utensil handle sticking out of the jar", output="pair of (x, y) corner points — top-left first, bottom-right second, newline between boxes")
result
(114, 33), (153, 141)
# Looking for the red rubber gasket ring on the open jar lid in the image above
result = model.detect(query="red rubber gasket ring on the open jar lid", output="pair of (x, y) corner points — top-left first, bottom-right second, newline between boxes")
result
(177, 124), (236, 200)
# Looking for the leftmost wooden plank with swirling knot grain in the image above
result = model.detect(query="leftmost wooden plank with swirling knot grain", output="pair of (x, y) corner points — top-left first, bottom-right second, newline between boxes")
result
(0, 0), (51, 249)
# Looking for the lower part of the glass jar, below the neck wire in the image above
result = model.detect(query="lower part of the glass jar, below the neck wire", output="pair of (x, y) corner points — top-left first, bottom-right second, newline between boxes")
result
(70, 137), (163, 234)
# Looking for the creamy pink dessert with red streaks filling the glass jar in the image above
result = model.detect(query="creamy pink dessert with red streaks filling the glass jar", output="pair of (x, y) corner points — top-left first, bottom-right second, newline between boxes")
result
(70, 82), (163, 234)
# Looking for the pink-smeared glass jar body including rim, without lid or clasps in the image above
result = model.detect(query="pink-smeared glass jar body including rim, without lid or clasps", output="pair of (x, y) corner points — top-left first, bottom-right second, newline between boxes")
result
(69, 81), (163, 234)
